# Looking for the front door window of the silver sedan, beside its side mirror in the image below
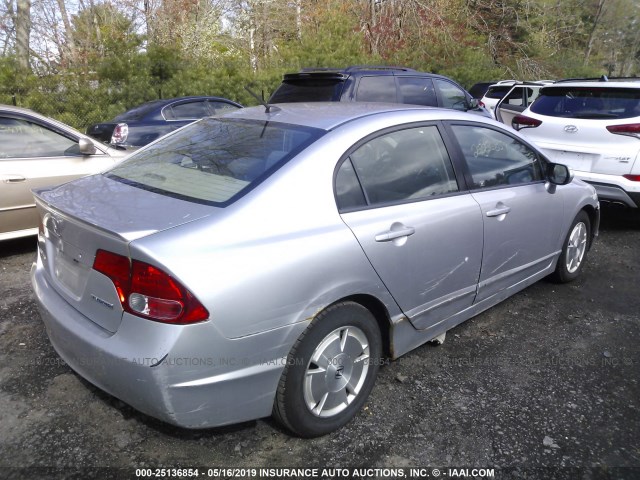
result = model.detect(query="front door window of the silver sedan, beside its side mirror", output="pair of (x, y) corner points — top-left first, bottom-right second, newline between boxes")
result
(452, 125), (543, 189)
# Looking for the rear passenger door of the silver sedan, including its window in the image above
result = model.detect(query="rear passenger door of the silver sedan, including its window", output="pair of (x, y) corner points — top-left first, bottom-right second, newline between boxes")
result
(336, 125), (483, 329)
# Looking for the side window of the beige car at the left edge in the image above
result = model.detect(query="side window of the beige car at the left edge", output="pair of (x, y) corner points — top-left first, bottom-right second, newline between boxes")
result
(0, 117), (81, 158)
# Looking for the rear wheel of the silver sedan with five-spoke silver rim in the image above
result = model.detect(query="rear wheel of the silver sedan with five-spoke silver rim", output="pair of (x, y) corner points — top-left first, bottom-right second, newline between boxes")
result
(273, 302), (382, 438)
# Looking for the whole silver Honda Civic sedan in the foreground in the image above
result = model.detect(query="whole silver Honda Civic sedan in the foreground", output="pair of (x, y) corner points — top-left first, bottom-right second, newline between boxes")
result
(31, 103), (599, 437)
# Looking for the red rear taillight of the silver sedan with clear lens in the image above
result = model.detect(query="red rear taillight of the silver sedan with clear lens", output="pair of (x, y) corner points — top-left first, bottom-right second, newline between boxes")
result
(93, 250), (209, 324)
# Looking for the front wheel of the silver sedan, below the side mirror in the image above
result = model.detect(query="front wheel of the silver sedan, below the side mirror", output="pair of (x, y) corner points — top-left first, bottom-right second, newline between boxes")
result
(551, 210), (591, 283)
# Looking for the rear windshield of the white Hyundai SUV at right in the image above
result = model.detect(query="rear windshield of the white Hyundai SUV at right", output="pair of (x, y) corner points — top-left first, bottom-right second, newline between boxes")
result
(531, 87), (640, 120)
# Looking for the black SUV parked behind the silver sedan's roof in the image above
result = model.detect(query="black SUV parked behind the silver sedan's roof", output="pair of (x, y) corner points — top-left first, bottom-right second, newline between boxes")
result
(269, 65), (490, 116)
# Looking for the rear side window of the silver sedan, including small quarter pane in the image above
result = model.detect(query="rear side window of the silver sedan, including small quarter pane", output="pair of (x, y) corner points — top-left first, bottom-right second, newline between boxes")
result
(336, 126), (458, 209)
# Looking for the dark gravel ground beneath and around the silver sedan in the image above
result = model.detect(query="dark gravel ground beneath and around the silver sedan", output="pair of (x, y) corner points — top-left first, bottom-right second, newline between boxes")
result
(0, 207), (640, 479)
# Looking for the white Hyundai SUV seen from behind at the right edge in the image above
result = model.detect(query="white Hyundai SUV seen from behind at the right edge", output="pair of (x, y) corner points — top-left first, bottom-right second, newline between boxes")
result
(504, 77), (640, 208)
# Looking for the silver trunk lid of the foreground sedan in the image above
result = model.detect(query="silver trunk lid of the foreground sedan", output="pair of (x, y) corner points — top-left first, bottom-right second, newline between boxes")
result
(34, 175), (215, 333)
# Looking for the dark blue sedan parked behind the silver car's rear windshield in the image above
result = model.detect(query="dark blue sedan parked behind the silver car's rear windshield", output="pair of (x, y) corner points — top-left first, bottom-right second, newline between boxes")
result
(87, 97), (242, 147)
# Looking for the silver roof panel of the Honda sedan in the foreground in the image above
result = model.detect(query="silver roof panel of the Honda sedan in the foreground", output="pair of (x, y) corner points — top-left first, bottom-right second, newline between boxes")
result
(222, 102), (479, 130)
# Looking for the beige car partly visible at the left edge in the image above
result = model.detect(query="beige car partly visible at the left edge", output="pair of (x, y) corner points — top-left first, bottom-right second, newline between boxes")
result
(0, 105), (127, 241)
